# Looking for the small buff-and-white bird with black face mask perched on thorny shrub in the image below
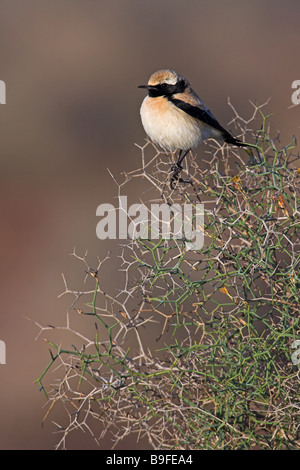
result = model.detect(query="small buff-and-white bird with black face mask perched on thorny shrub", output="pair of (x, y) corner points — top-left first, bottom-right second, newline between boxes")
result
(138, 69), (253, 187)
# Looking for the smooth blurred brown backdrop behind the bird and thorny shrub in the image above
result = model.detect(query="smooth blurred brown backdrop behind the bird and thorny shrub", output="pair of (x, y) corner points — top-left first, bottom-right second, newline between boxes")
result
(0, 0), (300, 449)
